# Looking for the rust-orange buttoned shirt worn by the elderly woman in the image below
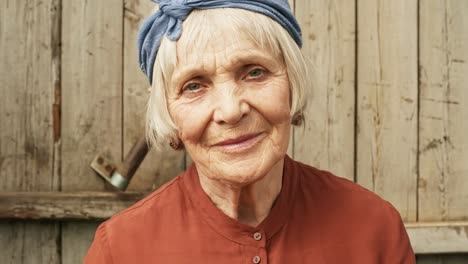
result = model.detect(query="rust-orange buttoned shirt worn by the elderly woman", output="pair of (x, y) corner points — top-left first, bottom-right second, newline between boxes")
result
(85, 156), (415, 264)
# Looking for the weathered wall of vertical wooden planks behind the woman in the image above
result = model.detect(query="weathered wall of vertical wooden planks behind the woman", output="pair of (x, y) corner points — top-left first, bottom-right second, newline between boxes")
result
(0, 0), (468, 264)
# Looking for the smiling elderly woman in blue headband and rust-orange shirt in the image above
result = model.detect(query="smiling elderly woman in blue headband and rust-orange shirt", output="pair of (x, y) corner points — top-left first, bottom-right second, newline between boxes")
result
(85, 0), (415, 264)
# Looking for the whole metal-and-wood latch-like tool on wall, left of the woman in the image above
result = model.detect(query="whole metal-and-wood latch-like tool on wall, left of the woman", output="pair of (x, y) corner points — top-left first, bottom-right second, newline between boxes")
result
(91, 136), (149, 191)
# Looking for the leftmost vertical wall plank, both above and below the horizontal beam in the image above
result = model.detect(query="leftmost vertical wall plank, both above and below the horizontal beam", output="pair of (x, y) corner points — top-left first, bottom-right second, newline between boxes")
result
(0, 0), (60, 263)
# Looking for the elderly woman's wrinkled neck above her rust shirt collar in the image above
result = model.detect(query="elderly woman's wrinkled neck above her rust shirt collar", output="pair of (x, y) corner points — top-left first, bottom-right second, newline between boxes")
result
(199, 159), (284, 227)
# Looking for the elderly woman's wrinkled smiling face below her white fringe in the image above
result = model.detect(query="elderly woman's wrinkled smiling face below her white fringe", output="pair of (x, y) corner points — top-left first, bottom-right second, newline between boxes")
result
(168, 32), (291, 186)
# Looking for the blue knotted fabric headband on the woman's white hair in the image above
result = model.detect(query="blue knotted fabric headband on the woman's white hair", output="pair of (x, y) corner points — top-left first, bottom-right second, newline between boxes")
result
(137, 0), (302, 84)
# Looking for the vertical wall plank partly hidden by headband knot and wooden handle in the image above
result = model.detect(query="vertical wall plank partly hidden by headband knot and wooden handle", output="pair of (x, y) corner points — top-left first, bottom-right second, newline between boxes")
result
(123, 0), (185, 191)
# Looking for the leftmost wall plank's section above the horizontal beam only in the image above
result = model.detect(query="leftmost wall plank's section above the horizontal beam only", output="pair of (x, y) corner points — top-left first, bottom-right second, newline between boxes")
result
(0, 0), (54, 191)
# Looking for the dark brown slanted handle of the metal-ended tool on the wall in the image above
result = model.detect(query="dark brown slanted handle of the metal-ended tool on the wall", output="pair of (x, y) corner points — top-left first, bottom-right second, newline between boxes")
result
(117, 136), (149, 181)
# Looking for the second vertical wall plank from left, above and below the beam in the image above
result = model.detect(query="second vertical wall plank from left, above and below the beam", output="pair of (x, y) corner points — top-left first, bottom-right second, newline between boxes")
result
(61, 0), (123, 263)
